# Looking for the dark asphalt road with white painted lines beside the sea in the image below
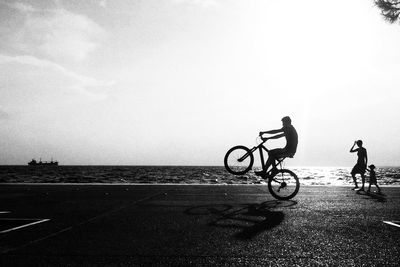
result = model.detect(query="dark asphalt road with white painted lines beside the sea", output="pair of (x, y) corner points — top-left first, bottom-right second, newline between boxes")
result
(0, 184), (400, 266)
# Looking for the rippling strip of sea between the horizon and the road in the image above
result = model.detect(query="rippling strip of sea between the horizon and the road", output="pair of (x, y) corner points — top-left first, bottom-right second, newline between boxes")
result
(0, 166), (400, 186)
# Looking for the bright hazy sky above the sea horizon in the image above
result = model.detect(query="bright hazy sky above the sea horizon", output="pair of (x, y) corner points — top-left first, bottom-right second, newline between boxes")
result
(0, 0), (400, 167)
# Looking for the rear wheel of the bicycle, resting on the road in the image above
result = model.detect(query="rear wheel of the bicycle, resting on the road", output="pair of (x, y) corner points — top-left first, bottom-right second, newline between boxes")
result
(268, 169), (300, 200)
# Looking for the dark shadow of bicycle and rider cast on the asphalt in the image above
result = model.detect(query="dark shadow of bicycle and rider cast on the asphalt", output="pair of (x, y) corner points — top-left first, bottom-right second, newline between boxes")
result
(184, 200), (297, 240)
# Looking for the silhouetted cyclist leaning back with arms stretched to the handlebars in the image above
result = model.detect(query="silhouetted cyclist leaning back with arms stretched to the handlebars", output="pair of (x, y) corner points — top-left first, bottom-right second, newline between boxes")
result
(255, 116), (298, 177)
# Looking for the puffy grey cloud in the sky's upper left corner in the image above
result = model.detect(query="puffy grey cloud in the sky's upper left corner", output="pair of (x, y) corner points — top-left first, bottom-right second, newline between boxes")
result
(8, 3), (105, 62)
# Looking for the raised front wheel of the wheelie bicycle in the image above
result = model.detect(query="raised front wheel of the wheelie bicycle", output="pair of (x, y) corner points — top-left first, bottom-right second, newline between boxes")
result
(224, 146), (254, 175)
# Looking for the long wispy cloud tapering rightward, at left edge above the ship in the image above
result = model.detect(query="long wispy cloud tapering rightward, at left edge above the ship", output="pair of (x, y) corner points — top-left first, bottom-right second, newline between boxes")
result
(0, 55), (113, 100)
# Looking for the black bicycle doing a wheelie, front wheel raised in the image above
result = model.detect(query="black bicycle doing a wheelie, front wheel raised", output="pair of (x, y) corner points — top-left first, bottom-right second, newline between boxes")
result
(224, 137), (300, 200)
